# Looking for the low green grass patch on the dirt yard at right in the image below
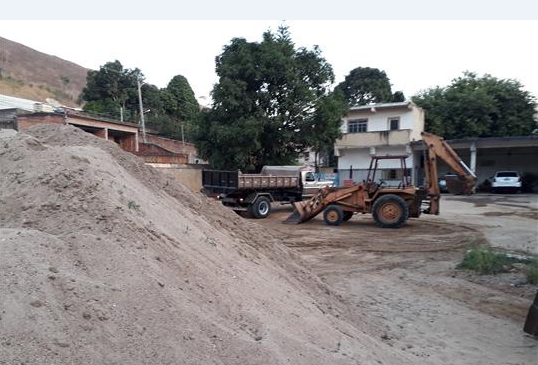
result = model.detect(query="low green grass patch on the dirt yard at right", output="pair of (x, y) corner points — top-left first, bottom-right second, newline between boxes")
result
(457, 249), (529, 275)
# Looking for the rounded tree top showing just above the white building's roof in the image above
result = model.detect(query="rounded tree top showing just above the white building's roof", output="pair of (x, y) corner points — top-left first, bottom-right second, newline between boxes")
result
(336, 67), (405, 105)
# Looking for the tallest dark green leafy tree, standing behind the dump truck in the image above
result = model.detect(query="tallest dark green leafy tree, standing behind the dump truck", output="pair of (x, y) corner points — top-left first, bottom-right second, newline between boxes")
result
(195, 27), (343, 170)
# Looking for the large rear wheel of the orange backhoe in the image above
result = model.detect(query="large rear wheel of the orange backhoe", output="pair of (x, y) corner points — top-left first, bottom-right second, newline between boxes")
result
(372, 194), (409, 228)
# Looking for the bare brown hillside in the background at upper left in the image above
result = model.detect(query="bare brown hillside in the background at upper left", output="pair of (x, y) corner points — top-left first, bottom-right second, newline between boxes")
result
(0, 37), (88, 106)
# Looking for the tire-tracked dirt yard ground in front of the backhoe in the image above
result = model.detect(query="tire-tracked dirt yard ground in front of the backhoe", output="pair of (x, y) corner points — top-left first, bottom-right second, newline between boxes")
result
(258, 194), (538, 365)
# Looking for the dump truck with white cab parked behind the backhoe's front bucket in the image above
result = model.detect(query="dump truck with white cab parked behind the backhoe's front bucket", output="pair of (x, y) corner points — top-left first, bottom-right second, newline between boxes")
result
(202, 166), (334, 219)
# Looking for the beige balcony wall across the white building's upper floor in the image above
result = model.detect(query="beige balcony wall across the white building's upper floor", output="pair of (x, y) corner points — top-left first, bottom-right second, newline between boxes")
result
(334, 129), (412, 149)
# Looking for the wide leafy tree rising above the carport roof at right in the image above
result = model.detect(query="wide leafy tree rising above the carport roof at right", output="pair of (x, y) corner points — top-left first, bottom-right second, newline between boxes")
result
(413, 72), (536, 138)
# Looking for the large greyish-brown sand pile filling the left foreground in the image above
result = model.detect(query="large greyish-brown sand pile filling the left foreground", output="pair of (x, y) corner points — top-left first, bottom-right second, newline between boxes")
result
(0, 126), (409, 364)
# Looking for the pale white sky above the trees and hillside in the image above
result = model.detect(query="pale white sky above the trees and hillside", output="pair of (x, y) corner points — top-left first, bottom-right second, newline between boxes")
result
(0, 20), (538, 105)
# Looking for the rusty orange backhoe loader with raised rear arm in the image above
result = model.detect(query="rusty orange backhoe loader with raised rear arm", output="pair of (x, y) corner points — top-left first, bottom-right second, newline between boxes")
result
(285, 132), (477, 228)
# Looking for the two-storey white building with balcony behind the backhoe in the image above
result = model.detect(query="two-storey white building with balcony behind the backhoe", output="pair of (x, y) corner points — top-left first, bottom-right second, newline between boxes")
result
(334, 102), (424, 185)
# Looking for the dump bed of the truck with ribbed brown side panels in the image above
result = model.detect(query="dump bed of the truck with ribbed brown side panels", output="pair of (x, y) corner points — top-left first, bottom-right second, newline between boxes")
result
(202, 170), (300, 191)
